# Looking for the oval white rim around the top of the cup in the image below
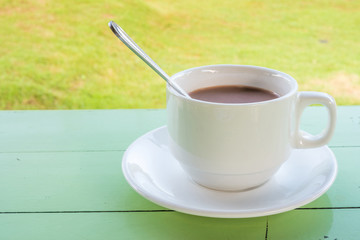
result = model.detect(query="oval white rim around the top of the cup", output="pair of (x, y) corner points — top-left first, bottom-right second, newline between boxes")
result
(166, 64), (298, 106)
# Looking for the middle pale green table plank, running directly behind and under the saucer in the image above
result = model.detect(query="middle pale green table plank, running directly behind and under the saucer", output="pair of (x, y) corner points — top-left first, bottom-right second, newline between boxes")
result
(0, 147), (360, 212)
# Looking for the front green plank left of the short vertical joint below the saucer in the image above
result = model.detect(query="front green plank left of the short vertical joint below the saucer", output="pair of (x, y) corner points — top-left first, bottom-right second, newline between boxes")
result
(0, 212), (266, 240)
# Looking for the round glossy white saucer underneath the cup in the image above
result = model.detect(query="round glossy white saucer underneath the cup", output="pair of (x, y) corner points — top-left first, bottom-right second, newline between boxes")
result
(122, 127), (337, 218)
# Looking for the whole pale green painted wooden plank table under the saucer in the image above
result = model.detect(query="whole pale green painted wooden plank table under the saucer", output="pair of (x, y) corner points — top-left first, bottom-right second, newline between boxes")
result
(0, 106), (360, 240)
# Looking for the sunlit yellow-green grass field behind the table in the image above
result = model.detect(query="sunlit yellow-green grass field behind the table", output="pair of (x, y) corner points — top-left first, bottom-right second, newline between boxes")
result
(0, 0), (360, 109)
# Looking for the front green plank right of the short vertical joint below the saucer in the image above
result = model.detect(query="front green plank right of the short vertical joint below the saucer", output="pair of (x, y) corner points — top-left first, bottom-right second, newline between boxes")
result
(267, 209), (360, 240)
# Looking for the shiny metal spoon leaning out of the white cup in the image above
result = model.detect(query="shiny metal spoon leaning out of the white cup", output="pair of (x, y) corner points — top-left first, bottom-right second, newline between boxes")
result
(109, 21), (191, 98)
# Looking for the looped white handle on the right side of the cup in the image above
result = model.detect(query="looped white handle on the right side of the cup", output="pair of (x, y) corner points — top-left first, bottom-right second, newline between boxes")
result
(293, 92), (336, 148)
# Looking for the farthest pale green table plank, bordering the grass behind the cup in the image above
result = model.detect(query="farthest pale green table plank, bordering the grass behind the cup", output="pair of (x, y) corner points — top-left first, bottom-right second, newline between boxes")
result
(0, 106), (360, 152)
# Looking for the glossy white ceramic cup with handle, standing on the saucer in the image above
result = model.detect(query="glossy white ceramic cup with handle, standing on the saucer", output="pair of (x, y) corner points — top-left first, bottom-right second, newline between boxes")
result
(167, 65), (336, 191)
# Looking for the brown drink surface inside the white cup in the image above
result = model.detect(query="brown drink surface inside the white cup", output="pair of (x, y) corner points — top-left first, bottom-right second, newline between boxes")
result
(189, 85), (280, 103)
